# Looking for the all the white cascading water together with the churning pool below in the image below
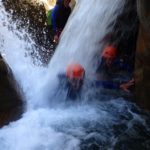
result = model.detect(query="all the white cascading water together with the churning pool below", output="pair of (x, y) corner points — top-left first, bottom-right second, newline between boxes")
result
(0, 0), (150, 150)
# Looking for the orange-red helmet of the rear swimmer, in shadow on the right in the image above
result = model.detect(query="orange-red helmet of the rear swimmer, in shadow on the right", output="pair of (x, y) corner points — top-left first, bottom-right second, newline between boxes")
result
(102, 46), (117, 58)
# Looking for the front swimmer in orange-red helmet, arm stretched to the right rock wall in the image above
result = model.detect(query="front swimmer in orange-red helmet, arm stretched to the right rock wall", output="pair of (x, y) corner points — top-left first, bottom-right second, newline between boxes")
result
(59, 63), (134, 99)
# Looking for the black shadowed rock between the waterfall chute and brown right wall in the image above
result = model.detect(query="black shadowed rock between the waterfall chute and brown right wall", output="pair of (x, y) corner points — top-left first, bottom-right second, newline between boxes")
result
(101, 0), (139, 79)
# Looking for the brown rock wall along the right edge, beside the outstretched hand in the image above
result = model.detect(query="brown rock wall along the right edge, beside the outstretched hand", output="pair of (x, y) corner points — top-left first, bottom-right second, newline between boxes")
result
(135, 0), (150, 110)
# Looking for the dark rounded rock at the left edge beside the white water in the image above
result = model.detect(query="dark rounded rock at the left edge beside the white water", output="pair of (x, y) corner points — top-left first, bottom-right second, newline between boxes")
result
(0, 54), (23, 127)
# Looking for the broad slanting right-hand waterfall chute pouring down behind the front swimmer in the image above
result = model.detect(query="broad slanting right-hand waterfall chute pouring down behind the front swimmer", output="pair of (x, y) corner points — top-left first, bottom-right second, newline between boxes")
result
(50, 0), (124, 72)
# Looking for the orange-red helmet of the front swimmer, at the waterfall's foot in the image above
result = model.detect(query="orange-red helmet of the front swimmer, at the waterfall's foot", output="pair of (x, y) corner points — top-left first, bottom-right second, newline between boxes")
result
(66, 63), (85, 79)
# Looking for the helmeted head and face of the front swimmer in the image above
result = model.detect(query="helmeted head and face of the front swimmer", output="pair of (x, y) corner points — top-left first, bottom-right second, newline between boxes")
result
(66, 63), (85, 90)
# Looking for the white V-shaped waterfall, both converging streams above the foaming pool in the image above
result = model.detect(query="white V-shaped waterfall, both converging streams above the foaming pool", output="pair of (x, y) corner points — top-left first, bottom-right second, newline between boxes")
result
(1, 0), (124, 108)
